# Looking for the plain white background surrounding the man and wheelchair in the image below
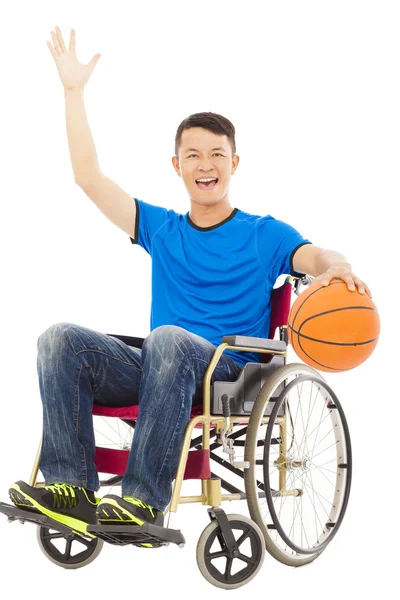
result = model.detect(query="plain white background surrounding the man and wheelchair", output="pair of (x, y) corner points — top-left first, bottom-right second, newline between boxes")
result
(0, 0), (400, 600)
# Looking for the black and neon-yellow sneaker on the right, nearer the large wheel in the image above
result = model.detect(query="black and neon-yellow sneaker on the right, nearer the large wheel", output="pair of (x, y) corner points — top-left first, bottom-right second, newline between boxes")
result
(96, 494), (164, 548)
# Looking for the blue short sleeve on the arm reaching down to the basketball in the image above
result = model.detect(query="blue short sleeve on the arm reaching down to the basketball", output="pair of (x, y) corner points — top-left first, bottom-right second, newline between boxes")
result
(256, 215), (312, 279)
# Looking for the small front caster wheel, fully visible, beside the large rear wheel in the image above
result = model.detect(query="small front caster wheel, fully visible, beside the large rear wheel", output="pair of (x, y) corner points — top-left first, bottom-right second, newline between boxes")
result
(196, 514), (265, 590)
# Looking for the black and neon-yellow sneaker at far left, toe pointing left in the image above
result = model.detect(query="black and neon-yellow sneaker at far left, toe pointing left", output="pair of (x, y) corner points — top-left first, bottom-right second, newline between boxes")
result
(8, 481), (100, 537)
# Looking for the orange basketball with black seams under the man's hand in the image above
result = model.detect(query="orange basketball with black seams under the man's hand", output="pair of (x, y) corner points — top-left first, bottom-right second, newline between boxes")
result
(288, 277), (380, 373)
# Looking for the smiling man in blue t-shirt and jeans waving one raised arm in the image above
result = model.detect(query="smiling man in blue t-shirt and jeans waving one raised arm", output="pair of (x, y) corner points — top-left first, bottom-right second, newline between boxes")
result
(10, 28), (371, 544)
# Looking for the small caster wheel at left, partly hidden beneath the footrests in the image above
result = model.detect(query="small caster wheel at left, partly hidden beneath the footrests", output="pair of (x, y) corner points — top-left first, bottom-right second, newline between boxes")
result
(37, 526), (104, 569)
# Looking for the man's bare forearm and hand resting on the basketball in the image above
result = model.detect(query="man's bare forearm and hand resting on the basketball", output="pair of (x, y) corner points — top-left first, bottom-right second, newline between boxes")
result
(293, 244), (372, 298)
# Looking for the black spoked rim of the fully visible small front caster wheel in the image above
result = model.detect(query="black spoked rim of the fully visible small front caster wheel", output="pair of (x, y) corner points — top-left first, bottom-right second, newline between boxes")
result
(204, 519), (263, 585)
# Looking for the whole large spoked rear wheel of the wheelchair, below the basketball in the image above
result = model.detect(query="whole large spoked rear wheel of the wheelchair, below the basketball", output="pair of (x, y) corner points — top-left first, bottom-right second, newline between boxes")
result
(245, 364), (352, 566)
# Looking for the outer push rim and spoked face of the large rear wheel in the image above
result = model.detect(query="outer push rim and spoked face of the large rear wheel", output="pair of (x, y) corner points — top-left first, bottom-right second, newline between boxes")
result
(263, 375), (352, 554)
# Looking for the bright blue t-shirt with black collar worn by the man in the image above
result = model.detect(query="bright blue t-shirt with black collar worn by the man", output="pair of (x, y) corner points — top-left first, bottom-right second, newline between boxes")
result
(130, 198), (311, 366)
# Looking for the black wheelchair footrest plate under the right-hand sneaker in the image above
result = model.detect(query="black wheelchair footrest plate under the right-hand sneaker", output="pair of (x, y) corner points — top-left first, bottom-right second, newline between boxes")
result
(87, 523), (185, 546)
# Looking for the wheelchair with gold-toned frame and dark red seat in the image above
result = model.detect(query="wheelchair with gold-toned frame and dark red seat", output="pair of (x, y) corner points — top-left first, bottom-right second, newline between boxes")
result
(0, 276), (352, 589)
